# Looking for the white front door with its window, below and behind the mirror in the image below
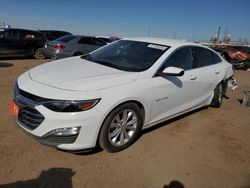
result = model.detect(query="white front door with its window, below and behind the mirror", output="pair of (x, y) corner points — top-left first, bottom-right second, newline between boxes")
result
(149, 47), (198, 124)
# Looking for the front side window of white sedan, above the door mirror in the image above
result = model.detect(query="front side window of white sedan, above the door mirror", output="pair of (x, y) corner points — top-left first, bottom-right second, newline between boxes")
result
(160, 47), (193, 71)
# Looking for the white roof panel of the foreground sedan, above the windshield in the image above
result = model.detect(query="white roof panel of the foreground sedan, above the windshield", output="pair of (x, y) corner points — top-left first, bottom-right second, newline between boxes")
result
(122, 37), (201, 47)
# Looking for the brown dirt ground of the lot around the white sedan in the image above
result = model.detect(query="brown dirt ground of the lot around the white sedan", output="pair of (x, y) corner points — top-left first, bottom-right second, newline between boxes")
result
(0, 59), (250, 188)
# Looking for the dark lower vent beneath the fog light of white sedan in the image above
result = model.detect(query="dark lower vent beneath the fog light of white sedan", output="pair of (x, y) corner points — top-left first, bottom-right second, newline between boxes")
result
(41, 134), (78, 145)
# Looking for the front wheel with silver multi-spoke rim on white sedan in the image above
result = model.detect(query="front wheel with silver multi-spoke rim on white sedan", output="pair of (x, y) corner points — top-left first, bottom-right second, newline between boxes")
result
(99, 103), (143, 153)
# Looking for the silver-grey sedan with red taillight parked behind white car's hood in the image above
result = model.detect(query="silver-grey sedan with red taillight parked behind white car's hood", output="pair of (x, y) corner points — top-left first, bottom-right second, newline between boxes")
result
(43, 35), (107, 59)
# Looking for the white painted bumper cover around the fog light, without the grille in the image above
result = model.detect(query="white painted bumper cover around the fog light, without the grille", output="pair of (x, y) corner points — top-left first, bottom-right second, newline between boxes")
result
(16, 106), (101, 150)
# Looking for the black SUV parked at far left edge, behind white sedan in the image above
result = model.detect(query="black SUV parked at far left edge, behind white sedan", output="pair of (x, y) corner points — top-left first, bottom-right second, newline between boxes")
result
(0, 28), (47, 59)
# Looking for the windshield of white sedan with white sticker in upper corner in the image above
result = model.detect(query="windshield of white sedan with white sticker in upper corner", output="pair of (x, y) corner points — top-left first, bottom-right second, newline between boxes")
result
(82, 40), (169, 72)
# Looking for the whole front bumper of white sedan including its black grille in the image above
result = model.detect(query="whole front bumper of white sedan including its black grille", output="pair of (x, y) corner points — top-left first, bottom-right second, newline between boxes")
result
(15, 83), (103, 151)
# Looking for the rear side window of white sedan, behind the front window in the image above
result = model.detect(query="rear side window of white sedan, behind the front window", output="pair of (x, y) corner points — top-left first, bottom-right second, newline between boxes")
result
(192, 47), (221, 68)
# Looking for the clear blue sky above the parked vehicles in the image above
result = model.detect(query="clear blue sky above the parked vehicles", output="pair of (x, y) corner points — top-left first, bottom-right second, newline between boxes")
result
(0, 0), (250, 41)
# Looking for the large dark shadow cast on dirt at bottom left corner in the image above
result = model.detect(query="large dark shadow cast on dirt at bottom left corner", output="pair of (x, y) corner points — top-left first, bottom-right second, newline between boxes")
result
(0, 168), (75, 188)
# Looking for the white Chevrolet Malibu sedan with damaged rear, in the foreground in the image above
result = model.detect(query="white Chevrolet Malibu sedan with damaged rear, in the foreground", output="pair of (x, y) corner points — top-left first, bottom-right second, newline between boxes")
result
(11, 38), (233, 152)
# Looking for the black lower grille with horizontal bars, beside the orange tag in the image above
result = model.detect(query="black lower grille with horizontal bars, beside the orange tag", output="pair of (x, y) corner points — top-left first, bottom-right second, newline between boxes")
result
(18, 107), (44, 130)
